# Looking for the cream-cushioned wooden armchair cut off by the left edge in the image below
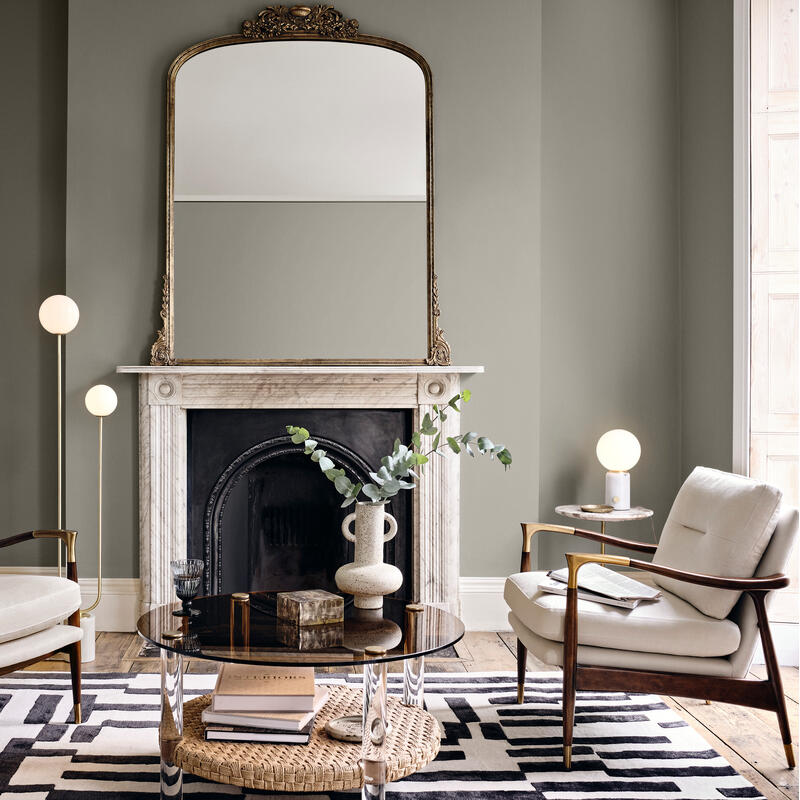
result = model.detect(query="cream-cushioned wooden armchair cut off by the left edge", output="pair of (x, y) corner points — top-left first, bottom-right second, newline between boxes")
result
(0, 530), (83, 724)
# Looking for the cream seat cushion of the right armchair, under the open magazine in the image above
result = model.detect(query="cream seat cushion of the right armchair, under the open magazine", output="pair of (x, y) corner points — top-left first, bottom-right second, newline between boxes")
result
(504, 572), (740, 658)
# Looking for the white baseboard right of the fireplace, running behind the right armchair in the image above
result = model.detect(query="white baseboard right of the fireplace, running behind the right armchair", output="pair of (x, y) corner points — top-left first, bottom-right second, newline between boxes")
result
(458, 577), (800, 667)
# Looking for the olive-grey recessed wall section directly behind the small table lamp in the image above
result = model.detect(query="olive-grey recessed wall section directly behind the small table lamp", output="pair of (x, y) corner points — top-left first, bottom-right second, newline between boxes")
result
(539, 0), (680, 564)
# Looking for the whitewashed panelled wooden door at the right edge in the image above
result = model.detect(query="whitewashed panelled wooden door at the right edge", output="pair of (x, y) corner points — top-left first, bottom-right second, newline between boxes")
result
(750, 0), (800, 623)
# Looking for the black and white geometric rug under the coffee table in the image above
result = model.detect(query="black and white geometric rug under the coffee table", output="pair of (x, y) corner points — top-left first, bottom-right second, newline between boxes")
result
(0, 672), (762, 800)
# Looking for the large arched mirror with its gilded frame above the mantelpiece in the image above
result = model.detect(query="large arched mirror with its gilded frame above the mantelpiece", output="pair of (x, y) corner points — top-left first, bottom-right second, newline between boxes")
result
(151, 6), (450, 364)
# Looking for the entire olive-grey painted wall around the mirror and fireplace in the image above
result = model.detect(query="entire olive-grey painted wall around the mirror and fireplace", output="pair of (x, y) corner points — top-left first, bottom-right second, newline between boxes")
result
(0, 0), (731, 588)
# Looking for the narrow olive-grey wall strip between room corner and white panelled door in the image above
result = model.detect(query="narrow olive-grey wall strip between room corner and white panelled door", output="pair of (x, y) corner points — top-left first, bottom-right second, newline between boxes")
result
(678, 0), (733, 476)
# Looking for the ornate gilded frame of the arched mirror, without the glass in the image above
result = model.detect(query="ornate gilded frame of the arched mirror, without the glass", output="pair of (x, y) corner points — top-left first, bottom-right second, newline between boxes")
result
(150, 6), (450, 366)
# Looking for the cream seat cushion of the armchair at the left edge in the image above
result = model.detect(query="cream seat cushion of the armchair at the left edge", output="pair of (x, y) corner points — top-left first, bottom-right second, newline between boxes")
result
(0, 575), (81, 642)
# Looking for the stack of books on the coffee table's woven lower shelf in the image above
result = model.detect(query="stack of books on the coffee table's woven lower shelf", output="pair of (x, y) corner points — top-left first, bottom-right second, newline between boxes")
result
(202, 664), (328, 744)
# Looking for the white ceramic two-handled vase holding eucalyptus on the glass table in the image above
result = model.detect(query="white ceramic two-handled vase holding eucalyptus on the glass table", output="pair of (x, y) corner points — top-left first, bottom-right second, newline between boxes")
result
(334, 503), (403, 608)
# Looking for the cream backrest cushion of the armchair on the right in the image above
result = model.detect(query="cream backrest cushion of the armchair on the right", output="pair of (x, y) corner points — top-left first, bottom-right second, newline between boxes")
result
(653, 467), (781, 619)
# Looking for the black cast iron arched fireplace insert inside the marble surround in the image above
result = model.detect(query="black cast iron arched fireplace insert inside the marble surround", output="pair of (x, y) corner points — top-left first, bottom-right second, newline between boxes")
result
(187, 409), (413, 600)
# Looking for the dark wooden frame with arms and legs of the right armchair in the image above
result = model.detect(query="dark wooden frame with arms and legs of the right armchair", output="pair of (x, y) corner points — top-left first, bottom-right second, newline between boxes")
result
(517, 522), (795, 769)
